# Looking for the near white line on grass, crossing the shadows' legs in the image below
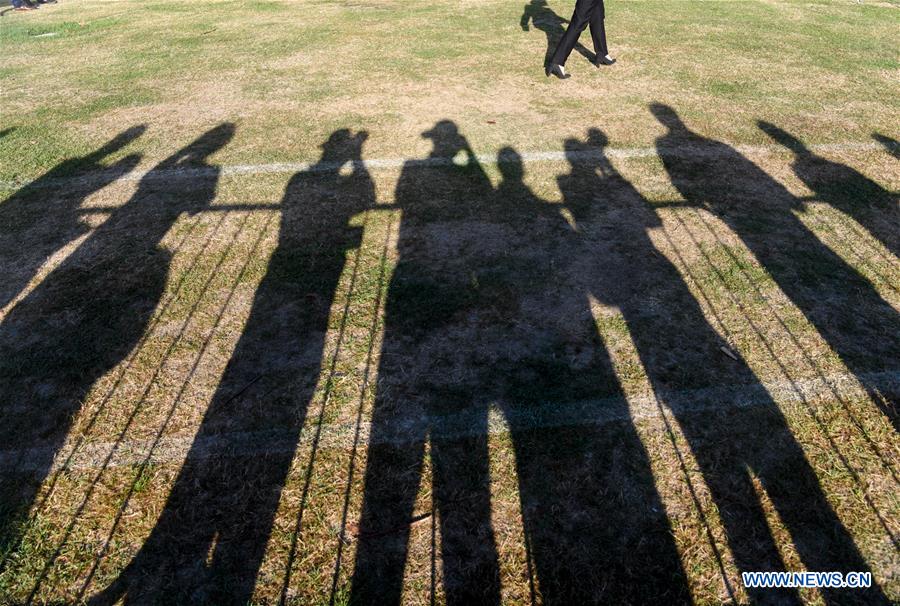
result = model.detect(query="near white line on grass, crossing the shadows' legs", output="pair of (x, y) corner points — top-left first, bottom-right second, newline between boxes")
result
(0, 371), (900, 473)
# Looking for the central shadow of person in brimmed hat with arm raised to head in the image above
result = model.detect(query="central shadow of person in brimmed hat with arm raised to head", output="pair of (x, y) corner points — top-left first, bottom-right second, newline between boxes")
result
(350, 120), (500, 605)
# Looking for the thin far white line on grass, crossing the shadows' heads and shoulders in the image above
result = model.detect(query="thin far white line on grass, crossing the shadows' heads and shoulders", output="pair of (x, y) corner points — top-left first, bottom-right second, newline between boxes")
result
(0, 142), (884, 189)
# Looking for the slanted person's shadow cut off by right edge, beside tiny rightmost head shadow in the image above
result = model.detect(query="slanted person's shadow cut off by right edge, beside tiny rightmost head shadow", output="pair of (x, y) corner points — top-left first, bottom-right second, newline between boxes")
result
(758, 121), (900, 257)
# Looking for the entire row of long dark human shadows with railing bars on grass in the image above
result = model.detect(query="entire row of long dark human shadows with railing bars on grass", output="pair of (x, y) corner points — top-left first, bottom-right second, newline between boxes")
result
(0, 110), (900, 604)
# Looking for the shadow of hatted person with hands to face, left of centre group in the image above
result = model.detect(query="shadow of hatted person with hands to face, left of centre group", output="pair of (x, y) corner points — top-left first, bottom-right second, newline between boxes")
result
(91, 129), (375, 604)
